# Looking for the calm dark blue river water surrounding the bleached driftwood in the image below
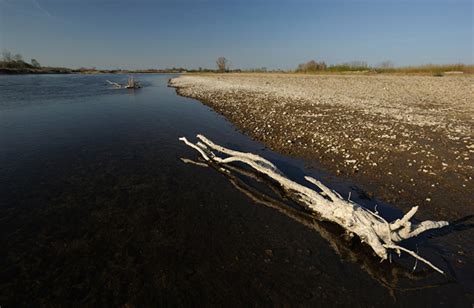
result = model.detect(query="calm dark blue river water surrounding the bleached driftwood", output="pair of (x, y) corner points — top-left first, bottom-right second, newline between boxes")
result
(0, 75), (472, 307)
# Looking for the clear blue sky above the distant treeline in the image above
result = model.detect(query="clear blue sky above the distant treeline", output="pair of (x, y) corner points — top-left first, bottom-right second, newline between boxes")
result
(0, 0), (474, 69)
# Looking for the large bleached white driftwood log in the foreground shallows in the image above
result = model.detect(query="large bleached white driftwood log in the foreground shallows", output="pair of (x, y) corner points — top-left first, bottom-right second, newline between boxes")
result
(179, 135), (448, 274)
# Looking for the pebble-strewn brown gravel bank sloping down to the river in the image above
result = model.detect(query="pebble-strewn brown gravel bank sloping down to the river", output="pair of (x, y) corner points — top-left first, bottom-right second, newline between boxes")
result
(170, 74), (474, 220)
